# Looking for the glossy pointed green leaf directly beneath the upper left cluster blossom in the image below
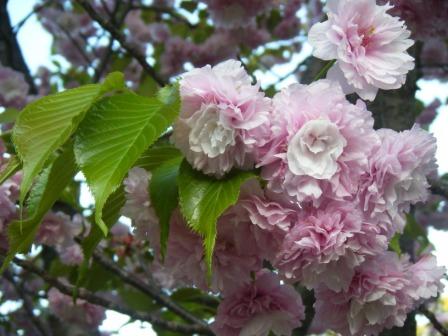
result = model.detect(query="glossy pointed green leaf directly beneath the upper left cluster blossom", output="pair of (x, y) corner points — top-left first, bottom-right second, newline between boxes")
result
(178, 161), (256, 277)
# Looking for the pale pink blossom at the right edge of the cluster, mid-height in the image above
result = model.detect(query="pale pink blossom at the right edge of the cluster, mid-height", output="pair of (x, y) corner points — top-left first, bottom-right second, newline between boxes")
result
(358, 126), (437, 237)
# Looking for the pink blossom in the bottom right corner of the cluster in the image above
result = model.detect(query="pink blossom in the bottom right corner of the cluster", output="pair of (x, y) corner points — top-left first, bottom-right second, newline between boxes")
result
(311, 252), (445, 336)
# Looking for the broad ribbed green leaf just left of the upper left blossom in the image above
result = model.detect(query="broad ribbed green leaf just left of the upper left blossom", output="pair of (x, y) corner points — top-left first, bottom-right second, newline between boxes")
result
(75, 87), (180, 234)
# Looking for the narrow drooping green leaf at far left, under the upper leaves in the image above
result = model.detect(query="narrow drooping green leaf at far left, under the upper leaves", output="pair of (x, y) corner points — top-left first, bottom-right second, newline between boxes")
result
(0, 144), (77, 272)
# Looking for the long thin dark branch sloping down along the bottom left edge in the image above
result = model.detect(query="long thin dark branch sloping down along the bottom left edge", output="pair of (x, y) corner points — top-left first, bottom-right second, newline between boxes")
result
(13, 258), (213, 335)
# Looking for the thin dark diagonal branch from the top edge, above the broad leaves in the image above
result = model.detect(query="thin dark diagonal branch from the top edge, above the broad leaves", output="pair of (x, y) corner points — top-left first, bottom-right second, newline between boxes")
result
(76, 0), (166, 86)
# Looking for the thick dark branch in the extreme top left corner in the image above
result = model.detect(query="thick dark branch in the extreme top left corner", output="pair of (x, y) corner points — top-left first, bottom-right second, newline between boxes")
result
(0, 0), (37, 94)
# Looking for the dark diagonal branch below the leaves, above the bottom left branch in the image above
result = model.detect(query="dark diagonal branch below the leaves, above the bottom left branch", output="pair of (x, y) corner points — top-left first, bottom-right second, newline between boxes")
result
(93, 251), (213, 330)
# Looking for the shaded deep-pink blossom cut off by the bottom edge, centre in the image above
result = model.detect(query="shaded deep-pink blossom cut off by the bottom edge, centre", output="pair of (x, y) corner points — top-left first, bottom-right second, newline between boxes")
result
(212, 270), (305, 336)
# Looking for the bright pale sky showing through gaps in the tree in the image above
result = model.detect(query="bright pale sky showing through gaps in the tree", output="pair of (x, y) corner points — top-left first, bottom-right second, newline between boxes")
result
(8, 0), (448, 336)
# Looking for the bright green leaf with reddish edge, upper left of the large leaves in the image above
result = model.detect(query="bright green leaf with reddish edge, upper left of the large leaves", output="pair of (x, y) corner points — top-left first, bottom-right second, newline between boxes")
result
(13, 73), (124, 203)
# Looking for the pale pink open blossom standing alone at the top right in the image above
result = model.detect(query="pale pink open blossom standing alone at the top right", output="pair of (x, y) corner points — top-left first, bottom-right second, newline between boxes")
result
(308, 0), (414, 100)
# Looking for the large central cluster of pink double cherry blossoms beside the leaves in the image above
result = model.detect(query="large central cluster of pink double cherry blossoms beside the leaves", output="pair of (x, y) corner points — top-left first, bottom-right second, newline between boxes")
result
(118, 53), (444, 335)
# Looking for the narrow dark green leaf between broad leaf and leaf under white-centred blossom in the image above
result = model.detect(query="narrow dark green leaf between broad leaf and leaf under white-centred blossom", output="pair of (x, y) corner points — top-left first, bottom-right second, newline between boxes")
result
(149, 157), (182, 258)
